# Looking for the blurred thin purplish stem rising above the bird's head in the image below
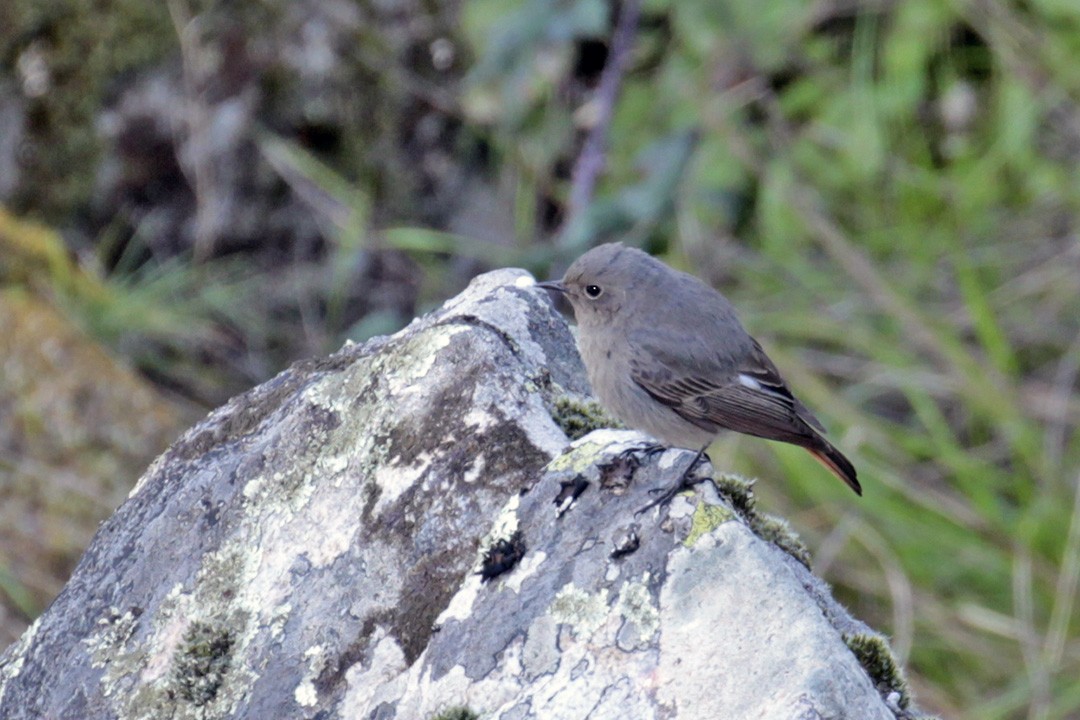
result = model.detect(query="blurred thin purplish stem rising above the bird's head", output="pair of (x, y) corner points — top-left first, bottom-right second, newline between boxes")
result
(568, 0), (642, 217)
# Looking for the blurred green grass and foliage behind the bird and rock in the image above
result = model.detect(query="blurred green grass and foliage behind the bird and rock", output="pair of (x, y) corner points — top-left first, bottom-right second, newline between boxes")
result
(0, 0), (1080, 720)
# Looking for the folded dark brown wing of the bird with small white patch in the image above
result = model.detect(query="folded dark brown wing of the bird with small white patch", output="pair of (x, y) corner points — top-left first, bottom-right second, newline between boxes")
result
(631, 340), (824, 445)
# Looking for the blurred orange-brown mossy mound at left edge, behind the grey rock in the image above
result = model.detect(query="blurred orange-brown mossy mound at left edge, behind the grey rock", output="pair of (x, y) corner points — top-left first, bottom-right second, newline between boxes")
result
(0, 208), (200, 646)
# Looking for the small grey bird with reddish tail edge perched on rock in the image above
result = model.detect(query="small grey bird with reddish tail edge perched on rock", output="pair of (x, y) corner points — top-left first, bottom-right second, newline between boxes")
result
(539, 243), (863, 494)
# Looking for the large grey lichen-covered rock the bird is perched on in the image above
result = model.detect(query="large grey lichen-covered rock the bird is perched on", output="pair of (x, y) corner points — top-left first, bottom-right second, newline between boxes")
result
(0, 271), (928, 720)
